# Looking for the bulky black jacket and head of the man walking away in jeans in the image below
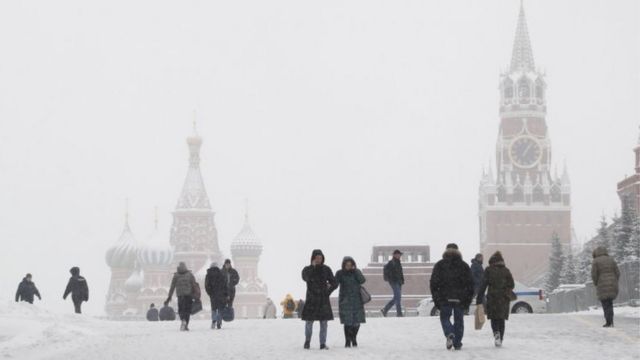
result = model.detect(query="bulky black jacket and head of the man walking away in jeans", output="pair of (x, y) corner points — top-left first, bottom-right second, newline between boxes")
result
(430, 249), (473, 308)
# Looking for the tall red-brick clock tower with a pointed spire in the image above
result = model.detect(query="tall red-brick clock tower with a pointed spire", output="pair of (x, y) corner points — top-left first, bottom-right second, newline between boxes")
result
(479, 4), (571, 285)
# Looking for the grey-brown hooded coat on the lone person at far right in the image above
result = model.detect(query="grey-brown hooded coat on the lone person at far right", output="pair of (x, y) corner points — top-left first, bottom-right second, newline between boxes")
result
(591, 246), (620, 301)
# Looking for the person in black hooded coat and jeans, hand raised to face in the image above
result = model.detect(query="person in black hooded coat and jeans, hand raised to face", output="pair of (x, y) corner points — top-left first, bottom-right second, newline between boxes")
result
(302, 249), (338, 350)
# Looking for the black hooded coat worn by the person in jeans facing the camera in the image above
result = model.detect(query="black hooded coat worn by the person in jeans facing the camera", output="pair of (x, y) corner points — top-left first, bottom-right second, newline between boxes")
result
(302, 250), (338, 321)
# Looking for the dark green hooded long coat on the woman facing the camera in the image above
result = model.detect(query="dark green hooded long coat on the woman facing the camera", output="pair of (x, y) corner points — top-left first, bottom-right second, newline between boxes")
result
(336, 257), (366, 325)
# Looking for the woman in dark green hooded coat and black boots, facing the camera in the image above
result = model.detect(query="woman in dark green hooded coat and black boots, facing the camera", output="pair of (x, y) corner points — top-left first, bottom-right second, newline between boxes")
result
(336, 256), (366, 347)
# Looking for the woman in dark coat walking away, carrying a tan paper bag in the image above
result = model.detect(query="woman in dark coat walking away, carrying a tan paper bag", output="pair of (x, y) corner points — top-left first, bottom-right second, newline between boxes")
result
(476, 251), (515, 346)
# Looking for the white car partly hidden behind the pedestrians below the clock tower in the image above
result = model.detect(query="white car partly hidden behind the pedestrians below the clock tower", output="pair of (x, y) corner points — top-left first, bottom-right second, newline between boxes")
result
(417, 281), (547, 316)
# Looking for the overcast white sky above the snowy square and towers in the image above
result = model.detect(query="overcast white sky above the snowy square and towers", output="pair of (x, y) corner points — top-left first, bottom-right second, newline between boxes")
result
(0, 0), (640, 314)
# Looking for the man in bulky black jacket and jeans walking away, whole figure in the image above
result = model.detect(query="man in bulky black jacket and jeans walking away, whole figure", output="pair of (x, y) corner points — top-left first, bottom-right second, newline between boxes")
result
(431, 244), (473, 350)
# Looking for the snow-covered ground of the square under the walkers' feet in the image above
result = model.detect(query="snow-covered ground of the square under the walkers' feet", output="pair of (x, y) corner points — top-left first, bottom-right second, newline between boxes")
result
(0, 303), (640, 360)
